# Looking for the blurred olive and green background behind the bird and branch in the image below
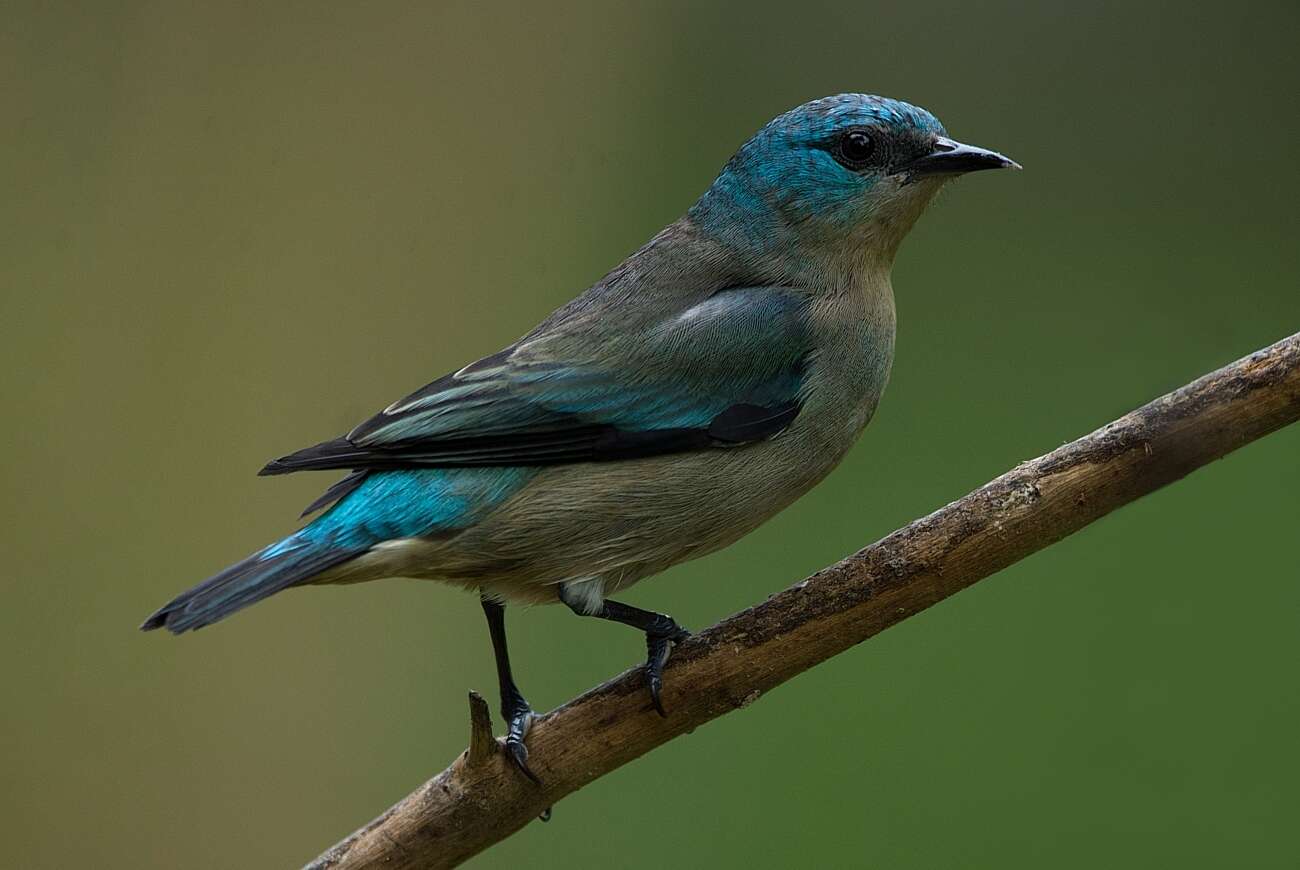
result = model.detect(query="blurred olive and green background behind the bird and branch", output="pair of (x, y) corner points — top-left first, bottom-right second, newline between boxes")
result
(0, 0), (1300, 867)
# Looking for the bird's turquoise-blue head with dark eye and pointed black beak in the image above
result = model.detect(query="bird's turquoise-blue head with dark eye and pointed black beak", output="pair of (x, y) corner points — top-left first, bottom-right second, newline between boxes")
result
(690, 94), (1019, 274)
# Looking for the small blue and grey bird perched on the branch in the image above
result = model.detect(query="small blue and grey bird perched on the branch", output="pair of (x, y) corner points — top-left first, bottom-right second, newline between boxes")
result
(142, 94), (1018, 780)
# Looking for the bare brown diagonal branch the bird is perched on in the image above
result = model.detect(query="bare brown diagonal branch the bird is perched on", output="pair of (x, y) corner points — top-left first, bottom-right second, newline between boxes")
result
(308, 333), (1300, 870)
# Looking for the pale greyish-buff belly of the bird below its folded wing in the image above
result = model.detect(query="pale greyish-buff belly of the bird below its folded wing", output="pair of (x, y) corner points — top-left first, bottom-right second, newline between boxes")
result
(385, 400), (853, 602)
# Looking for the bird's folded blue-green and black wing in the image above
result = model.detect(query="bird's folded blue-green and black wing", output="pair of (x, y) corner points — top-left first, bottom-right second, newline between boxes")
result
(261, 287), (810, 475)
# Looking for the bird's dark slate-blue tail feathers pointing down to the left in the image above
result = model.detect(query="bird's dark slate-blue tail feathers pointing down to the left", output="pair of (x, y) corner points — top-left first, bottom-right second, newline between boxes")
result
(140, 529), (365, 635)
